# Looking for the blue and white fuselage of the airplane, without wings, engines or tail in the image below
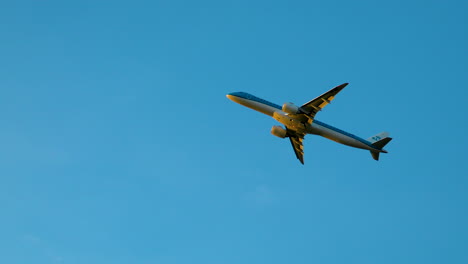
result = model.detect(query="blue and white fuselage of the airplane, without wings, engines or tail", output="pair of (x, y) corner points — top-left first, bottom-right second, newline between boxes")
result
(227, 92), (385, 152)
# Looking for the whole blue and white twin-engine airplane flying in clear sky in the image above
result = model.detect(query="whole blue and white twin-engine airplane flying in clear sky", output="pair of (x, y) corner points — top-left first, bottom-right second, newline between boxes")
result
(226, 83), (392, 164)
